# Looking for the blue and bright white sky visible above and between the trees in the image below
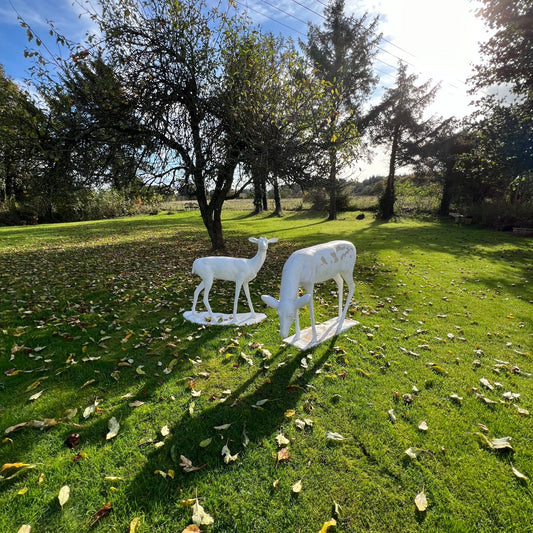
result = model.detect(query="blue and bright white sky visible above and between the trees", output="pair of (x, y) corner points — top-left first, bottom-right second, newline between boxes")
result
(0, 0), (488, 180)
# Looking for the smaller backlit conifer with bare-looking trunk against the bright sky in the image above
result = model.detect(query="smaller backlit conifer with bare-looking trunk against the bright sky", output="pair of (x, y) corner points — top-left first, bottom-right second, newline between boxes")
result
(372, 62), (438, 220)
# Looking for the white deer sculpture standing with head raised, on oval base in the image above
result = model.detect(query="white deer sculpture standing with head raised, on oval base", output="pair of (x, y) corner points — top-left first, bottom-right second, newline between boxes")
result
(192, 237), (278, 320)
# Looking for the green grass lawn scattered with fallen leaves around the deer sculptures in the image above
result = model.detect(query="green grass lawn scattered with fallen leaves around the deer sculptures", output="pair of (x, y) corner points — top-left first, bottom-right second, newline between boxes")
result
(0, 211), (533, 533)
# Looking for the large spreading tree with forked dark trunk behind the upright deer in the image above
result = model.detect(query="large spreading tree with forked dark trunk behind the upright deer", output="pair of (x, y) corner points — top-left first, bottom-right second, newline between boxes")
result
(31, 0), (280, 250)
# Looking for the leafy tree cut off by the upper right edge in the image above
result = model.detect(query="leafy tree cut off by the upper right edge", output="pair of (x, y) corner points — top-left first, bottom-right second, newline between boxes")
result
(462, 0), (533, 201)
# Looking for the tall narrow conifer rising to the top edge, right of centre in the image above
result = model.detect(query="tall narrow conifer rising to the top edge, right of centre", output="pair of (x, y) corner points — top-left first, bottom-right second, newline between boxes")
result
(301, 0), (381, 220)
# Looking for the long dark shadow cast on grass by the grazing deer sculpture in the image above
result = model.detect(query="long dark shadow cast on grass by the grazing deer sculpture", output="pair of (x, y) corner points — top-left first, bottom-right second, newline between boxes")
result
(117, 338), (336, 518)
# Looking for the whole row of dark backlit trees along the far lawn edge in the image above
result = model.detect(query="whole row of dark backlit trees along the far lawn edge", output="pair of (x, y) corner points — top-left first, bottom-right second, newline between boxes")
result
(0, 0), (533, 245)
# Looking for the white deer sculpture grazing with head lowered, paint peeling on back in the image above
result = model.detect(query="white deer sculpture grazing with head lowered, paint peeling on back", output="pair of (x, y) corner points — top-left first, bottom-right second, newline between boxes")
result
(261, 241), (356, 344)
